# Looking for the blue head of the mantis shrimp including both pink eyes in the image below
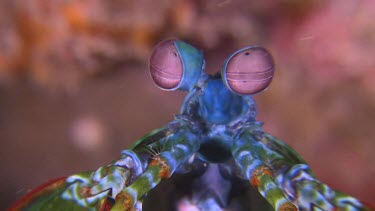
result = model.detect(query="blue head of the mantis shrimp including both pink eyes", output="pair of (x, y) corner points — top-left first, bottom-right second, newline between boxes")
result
(150, 39), (274, 125)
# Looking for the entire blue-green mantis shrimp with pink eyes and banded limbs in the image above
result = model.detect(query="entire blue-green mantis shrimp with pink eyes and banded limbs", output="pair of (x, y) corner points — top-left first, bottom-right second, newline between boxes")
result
(13, 40), (369, 210)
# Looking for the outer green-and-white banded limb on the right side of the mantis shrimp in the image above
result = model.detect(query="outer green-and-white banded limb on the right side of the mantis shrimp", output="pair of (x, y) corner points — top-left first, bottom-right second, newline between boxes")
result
(248, 133), (367, 210)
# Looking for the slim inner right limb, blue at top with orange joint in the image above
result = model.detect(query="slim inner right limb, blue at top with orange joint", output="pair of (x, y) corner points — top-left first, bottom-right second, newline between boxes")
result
(232, 133), (297, 211)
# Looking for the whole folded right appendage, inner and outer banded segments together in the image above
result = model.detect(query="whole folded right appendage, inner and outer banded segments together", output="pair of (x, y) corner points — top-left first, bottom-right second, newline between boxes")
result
(232, 131), (370, 210)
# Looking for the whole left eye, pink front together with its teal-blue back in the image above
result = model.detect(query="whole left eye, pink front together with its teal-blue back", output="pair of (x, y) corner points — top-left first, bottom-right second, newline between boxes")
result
(150, 40), (204, 90)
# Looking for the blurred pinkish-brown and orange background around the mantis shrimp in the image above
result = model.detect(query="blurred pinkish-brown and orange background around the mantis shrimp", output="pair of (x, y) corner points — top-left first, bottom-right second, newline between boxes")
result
(0, 0), (375, 210)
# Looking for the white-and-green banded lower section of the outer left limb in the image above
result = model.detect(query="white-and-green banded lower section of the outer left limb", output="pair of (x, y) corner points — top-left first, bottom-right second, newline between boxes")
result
(62, 150), (146, 207)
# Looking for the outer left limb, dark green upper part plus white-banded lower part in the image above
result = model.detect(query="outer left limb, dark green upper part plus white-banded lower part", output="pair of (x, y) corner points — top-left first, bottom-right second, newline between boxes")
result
(61, 128), (168, 207)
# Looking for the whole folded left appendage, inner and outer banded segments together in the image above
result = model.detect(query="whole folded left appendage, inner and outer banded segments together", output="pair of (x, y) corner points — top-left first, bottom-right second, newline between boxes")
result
(61, 123), (199, 210)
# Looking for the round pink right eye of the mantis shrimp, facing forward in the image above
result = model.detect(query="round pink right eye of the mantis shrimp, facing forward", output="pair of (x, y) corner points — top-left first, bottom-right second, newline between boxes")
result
(222, 46), (275, 95)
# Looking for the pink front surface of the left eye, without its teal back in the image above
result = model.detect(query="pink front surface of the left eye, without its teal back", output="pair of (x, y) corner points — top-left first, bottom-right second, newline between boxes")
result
(150, 40), (183, 90)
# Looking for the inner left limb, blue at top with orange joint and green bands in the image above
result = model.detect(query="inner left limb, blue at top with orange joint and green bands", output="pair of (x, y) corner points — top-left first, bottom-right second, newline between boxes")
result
(113, 126), (199, 210)
